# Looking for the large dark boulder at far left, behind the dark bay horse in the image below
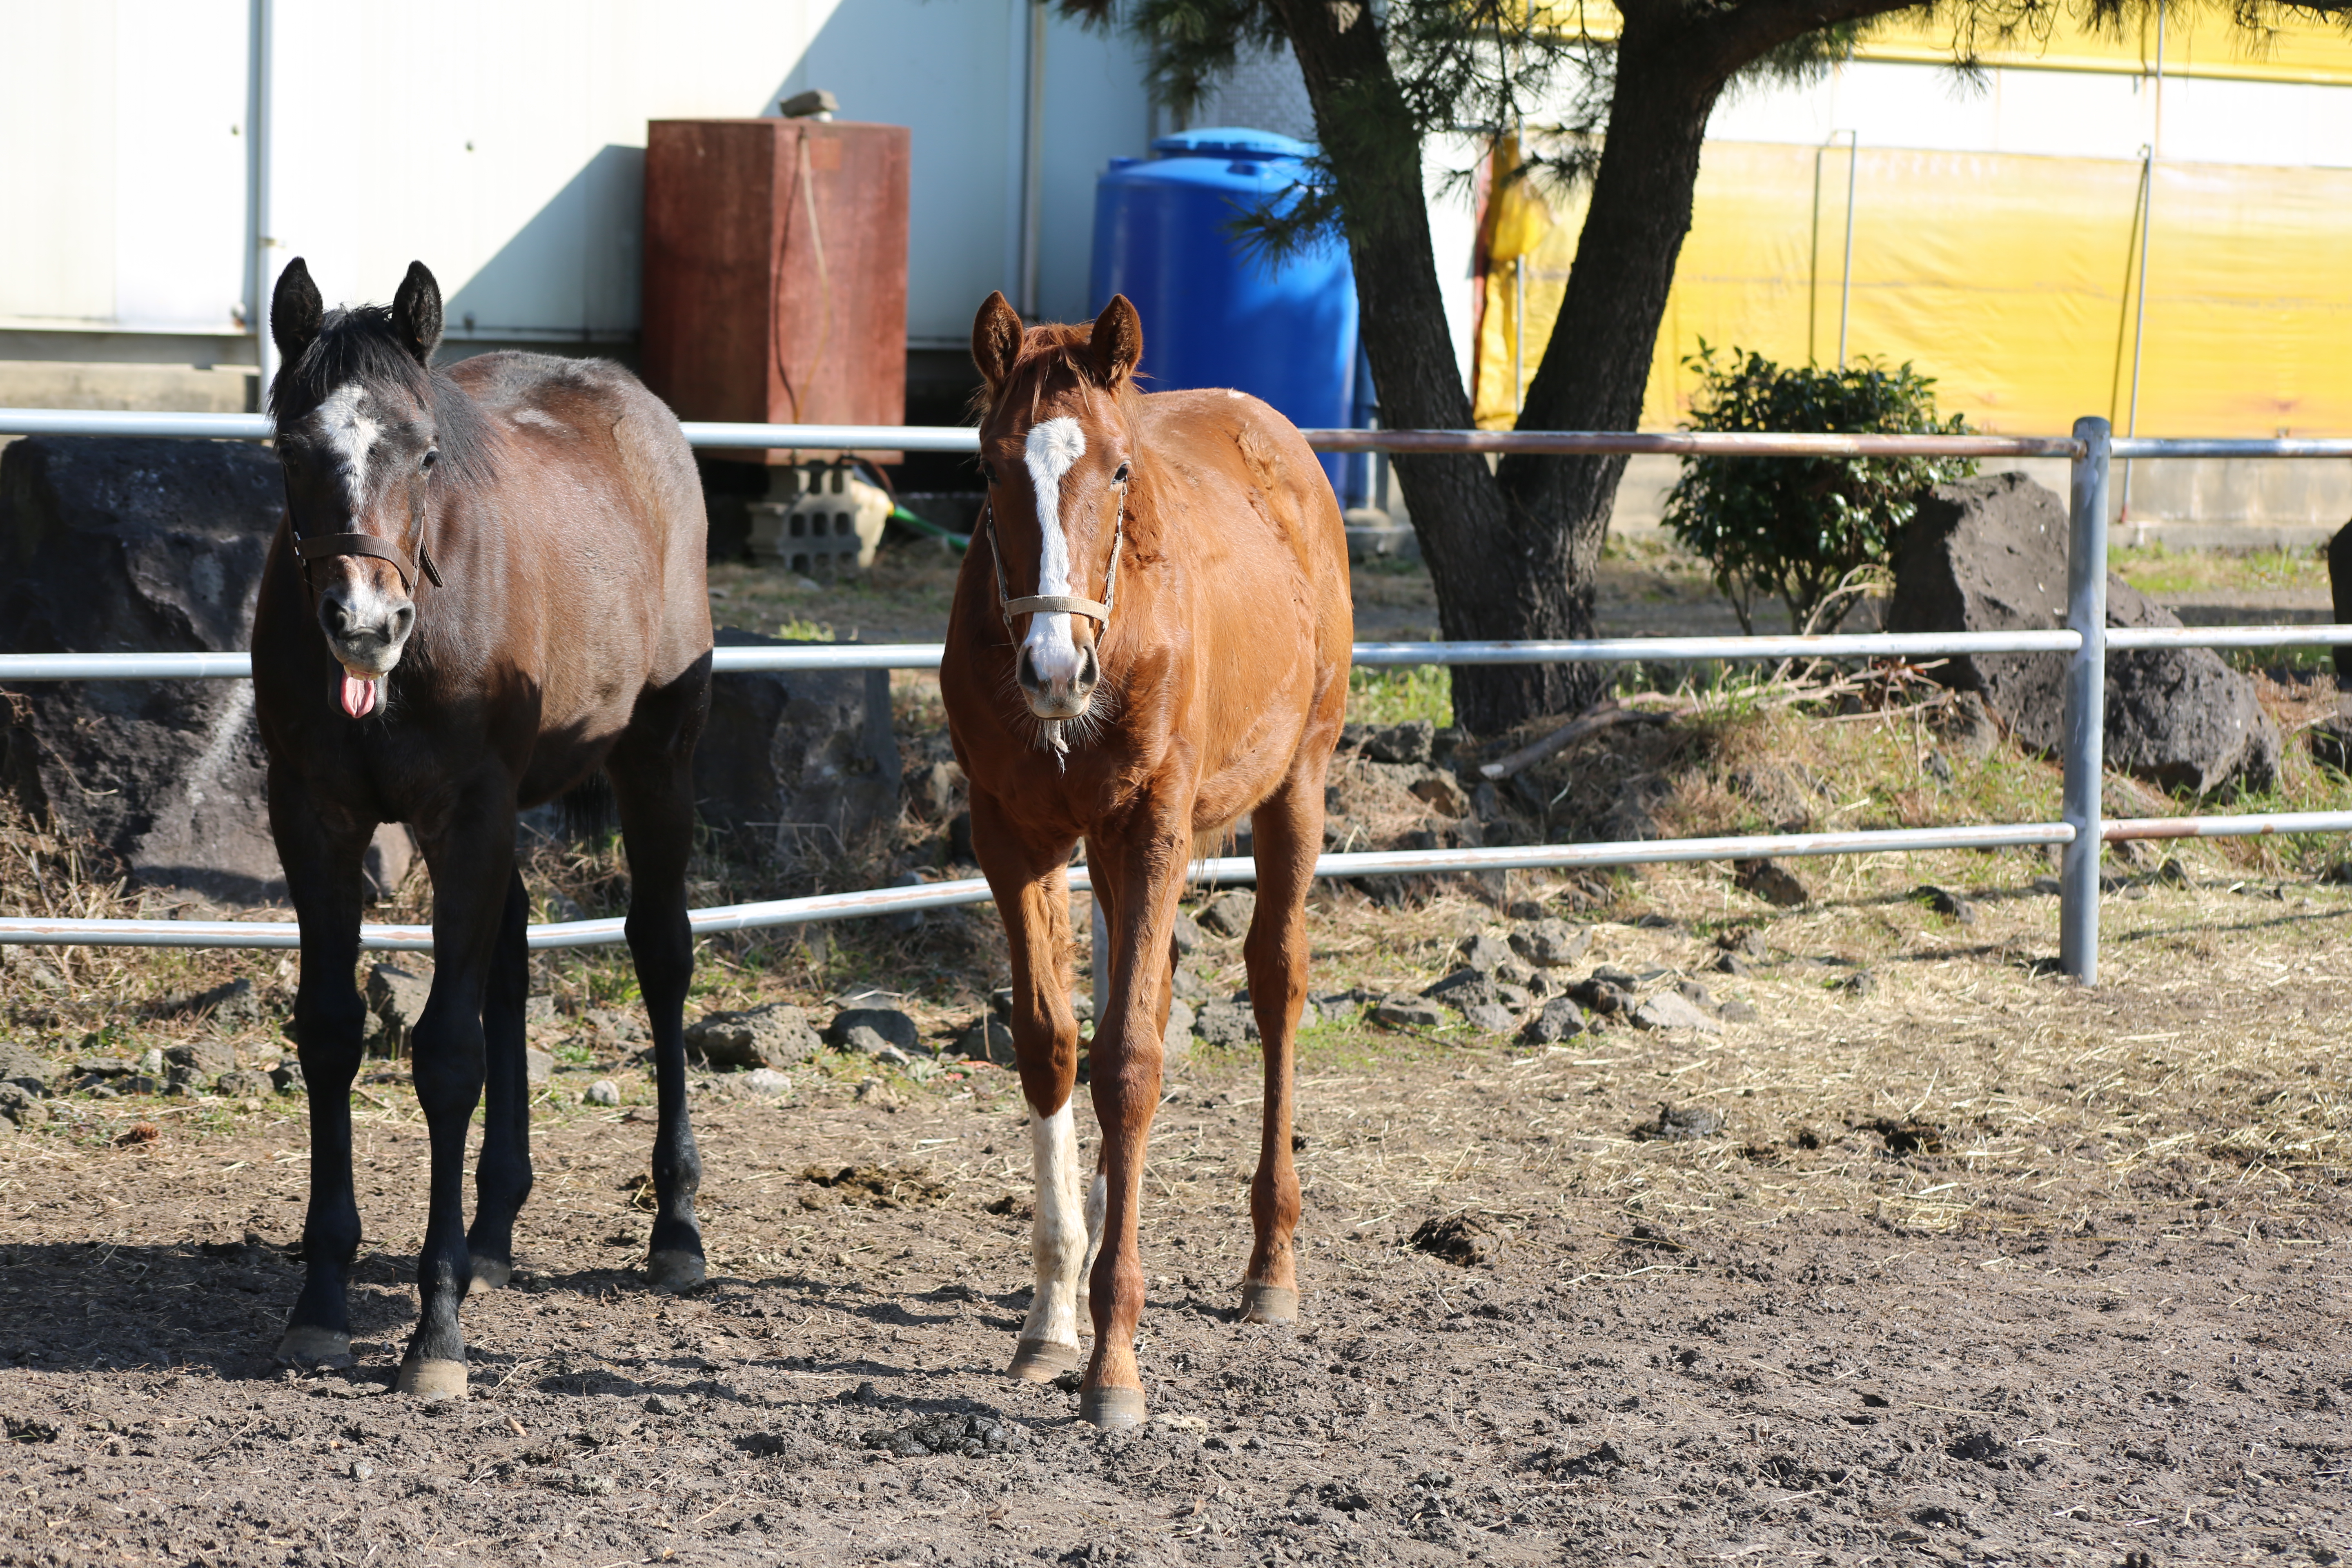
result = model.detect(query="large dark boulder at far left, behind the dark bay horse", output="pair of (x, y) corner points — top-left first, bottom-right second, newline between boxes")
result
(0, 437), (409, 903)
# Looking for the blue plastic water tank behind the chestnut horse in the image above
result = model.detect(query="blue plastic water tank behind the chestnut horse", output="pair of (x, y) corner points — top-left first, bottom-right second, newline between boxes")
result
(1089, 127), (1364, 506)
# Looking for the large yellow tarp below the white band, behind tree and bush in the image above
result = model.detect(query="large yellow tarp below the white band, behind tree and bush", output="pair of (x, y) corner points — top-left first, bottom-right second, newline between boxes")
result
(1477, 141), (2352, 435)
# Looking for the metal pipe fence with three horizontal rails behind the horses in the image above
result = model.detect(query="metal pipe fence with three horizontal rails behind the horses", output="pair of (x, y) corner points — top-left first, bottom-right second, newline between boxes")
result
(0, 409), (2352, 985)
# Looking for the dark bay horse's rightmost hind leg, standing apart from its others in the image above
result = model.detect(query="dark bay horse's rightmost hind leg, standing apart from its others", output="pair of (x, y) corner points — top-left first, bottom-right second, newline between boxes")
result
(604, 663), (710, 1291)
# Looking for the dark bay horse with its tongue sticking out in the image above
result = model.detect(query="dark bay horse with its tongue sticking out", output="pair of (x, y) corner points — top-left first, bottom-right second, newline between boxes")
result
(252, 261), (710, 1396)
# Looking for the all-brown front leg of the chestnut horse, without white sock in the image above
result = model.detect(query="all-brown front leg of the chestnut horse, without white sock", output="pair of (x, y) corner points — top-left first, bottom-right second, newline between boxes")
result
(1077, 792), (1192, 1427)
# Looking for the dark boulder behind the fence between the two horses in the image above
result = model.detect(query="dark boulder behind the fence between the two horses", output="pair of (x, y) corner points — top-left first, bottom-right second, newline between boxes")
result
(694, 628), (898, 860)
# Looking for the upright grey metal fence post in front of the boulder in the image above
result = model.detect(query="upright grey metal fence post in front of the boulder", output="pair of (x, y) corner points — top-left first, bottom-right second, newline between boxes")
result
(2058, 419), (2110, 985)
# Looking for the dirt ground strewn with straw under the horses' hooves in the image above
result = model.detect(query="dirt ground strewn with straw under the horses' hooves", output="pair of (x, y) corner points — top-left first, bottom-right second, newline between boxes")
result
(0, 856), (2352, 1566)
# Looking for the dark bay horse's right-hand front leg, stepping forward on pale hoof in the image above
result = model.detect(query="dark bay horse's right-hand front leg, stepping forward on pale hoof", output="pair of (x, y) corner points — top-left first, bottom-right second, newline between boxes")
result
(393, 776), (522, 1399)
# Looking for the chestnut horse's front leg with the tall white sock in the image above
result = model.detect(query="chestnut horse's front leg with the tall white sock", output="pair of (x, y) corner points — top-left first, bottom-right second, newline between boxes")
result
(971, 790), (1087, 1382)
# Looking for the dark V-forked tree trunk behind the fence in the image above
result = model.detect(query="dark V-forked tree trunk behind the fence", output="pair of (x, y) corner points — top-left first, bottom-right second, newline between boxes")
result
(1272, 0), (1722, 733)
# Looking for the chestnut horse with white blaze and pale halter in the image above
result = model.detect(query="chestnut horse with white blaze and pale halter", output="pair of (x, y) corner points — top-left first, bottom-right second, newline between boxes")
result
(941, 294), (1355, 1427)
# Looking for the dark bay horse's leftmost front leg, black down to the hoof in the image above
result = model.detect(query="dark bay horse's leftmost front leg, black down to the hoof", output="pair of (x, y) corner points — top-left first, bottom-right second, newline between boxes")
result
(268, 764), (374, 1366)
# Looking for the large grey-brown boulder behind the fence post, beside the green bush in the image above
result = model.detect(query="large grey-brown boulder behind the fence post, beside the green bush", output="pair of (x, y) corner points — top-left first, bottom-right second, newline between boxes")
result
(1886, 472), (2279, 795)
